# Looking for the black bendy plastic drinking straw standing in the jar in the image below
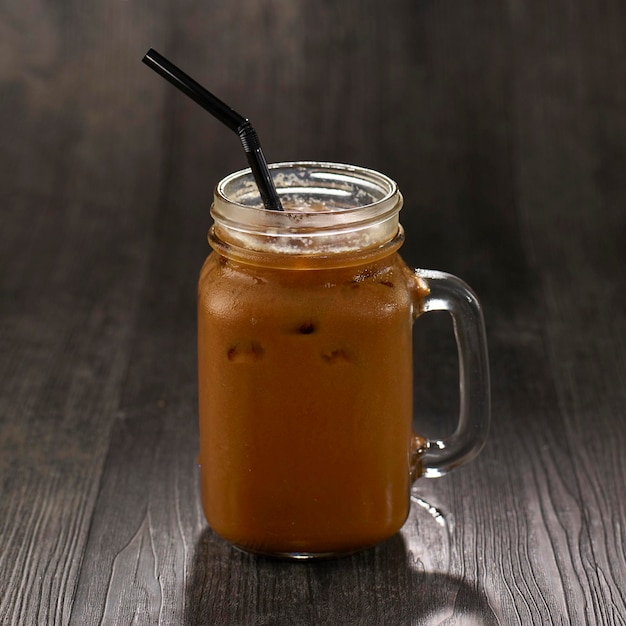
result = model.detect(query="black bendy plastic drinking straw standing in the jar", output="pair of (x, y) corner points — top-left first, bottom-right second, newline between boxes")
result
(142, 48), (283, 211)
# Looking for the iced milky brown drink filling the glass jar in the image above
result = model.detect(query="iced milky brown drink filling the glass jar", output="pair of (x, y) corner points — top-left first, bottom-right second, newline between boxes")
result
(198, 164), (488, 556)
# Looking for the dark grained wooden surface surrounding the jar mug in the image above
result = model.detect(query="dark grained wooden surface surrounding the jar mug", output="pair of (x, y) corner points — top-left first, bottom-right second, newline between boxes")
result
(0, 0), (626, 626)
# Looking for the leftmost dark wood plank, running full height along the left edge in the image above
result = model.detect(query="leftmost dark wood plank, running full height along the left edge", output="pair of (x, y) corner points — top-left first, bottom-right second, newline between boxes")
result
(0, 2), (169, 624)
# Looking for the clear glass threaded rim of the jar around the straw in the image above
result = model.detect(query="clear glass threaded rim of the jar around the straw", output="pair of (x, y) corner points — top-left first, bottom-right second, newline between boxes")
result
(211, 161), (403, 255)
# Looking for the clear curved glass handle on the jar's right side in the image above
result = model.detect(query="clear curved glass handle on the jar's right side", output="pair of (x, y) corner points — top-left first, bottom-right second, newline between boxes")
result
(413, 269), (490, 478)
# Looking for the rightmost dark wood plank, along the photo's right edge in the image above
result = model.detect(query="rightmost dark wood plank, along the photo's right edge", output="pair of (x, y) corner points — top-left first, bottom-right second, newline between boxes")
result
(508, 2), (626, 624)
